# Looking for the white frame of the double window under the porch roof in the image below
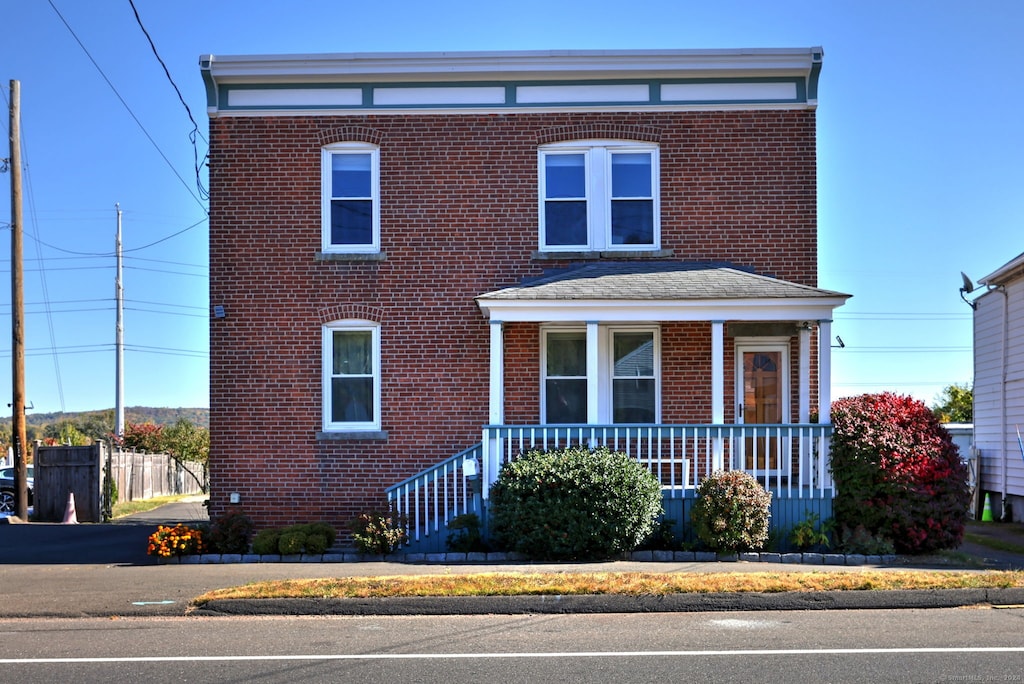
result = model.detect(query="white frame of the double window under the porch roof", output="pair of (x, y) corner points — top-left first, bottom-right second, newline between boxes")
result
(540, 324), (662, 425)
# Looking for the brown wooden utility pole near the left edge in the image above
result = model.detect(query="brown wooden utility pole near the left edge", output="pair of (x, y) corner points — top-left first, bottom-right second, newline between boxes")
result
(10, 80), (29, 520)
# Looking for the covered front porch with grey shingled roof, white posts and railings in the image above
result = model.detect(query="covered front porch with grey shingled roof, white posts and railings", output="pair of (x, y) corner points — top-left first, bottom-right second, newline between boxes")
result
(388, 261), (847, 550)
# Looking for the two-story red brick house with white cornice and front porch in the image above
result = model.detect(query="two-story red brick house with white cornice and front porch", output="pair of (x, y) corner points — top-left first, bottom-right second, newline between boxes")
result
(201, 48), (847, 545)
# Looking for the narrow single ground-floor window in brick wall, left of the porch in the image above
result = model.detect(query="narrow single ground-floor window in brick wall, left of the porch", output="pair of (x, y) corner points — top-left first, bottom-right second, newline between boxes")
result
(324, 320), (381, 431)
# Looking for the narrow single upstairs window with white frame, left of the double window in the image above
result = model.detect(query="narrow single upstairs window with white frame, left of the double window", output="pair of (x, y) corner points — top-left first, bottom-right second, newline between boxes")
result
(322, 142), (380, 252)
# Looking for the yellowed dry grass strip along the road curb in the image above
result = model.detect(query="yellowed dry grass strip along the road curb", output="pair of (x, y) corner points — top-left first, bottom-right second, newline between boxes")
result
(193, 570), (1024, 606)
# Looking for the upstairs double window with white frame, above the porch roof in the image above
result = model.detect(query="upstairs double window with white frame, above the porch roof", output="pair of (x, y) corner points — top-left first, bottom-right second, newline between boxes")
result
(540, 140), (660, 251)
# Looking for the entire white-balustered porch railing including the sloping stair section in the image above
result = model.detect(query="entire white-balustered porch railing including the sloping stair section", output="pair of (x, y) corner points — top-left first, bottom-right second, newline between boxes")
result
(386, 424), (835, 543)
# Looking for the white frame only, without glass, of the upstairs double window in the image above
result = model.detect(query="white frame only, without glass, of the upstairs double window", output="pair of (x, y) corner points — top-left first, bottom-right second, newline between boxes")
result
(538, 140), (662, 252)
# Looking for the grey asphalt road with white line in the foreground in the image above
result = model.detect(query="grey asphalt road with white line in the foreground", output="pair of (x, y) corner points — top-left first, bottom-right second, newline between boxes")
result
(0, 608), (1024, 684)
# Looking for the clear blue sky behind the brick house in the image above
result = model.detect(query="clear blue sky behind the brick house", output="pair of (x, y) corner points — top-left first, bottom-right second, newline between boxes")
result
(0, 0), (1024, 412)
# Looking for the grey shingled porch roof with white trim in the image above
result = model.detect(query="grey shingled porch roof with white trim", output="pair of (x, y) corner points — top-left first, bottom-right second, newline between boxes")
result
(476, 261), (850, 322)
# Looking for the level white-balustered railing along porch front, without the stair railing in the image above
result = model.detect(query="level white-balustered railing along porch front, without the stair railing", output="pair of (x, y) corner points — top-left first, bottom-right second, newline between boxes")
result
(482, 424), (834, 499)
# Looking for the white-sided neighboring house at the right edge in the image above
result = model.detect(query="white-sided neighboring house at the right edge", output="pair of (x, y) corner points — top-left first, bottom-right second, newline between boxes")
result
(974, 249), (1024, 520)
